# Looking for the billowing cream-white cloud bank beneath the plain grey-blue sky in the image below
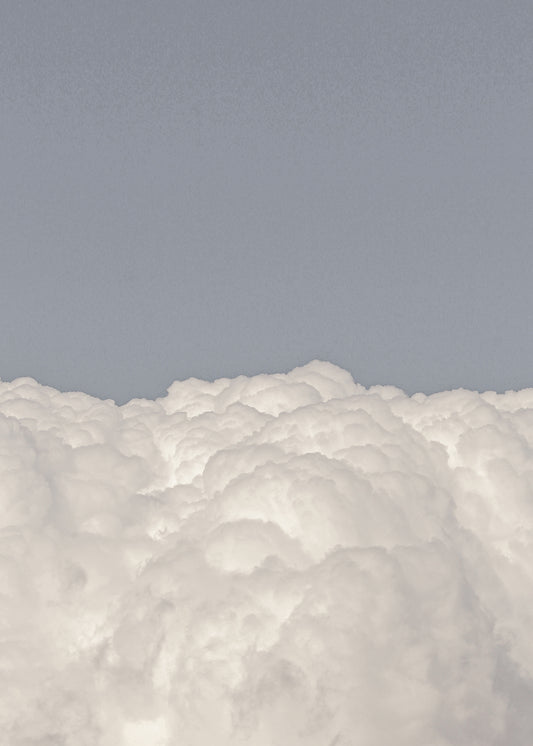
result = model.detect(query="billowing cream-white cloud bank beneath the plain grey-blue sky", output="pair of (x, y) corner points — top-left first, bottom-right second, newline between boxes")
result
(0, 361), (533, 746)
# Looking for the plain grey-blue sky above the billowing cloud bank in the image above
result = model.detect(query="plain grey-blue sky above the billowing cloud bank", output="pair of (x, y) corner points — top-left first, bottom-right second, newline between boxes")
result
(0, 0), (533, 402)
